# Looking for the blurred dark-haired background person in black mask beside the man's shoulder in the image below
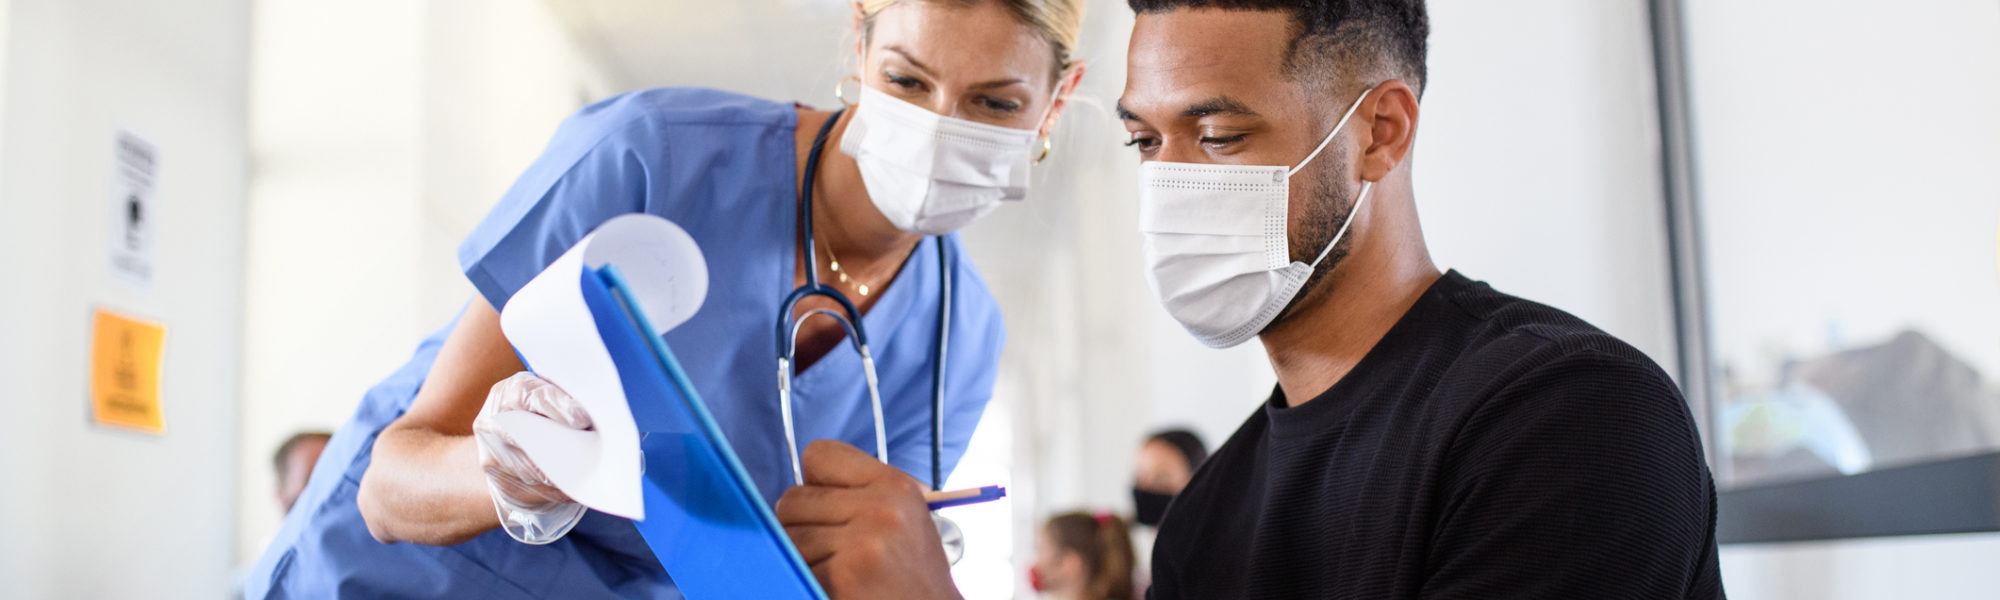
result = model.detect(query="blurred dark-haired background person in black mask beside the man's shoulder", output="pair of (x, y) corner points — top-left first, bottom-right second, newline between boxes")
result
(1132, 428), (1208, 590)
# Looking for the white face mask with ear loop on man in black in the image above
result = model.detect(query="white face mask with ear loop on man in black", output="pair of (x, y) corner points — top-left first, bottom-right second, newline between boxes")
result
(1138, 88), (1374, 348)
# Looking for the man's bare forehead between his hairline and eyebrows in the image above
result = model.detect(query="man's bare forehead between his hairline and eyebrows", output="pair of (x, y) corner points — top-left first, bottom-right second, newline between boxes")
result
(1122, 8), (1292, 112)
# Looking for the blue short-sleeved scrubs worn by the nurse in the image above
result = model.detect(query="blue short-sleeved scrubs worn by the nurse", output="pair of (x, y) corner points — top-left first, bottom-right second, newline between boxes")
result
(244, 90), (1002, 598)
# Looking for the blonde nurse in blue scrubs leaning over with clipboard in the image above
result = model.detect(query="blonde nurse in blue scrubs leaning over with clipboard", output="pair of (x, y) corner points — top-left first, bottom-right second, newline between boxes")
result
(244, 0), (1084, 598)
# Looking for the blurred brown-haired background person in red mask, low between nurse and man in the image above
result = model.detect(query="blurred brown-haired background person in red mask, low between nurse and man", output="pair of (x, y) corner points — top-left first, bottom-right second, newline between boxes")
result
(1028, 512), (1138, 600)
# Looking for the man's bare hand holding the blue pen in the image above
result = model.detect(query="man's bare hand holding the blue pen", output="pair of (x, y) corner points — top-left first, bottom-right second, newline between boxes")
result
(778, 440), (958, 598)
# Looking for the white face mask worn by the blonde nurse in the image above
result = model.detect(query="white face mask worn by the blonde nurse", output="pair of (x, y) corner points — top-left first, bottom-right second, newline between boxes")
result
(840, 86), (1036, 236)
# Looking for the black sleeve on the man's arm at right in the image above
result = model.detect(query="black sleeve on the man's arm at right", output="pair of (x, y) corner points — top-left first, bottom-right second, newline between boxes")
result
(1422, 348), (1720, 598)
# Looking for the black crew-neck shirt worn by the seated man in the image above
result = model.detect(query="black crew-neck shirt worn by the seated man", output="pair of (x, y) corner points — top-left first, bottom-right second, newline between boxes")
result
(1148, 272), (1724, 600)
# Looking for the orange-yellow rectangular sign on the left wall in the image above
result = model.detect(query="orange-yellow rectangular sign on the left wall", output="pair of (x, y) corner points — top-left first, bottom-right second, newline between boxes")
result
(90, 308), (166, 434)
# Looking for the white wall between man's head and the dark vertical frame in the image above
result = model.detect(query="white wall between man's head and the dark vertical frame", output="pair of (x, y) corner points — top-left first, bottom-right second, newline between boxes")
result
(1416, 0), (1676, 372)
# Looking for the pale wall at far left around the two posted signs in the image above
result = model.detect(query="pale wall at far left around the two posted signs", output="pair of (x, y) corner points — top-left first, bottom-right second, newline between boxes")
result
(0, 0), (248, 598)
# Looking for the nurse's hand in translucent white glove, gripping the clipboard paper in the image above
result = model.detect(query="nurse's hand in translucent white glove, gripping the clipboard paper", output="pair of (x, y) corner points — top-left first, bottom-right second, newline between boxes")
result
(472, 372), (590, 544)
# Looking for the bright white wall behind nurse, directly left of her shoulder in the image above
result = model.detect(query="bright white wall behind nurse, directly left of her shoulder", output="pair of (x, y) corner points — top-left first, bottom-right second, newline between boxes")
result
(236, 0), (604, 562)
